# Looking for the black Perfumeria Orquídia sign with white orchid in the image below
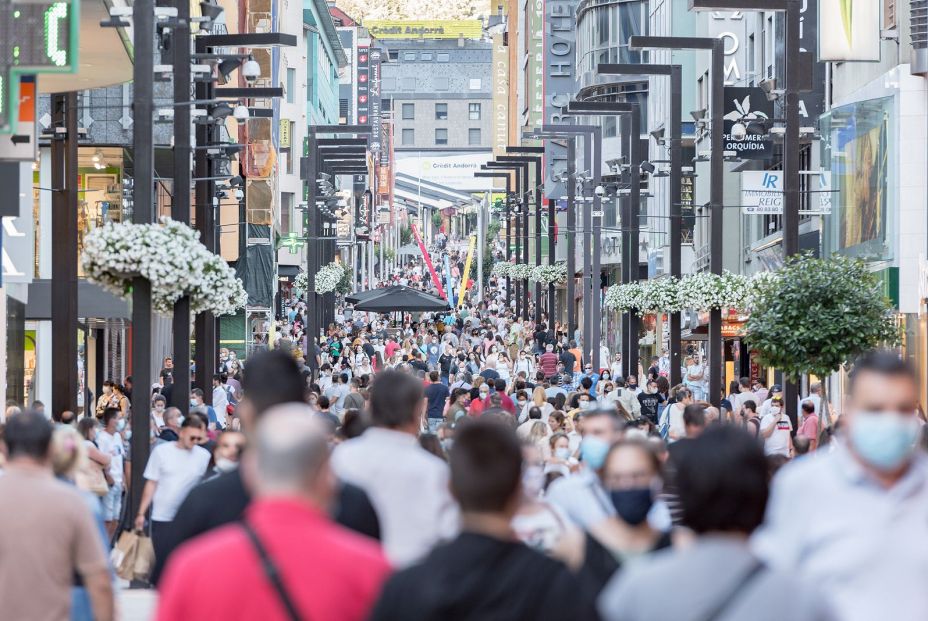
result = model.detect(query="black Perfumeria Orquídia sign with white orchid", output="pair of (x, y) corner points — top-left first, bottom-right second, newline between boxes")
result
(722, 86), (775, 160)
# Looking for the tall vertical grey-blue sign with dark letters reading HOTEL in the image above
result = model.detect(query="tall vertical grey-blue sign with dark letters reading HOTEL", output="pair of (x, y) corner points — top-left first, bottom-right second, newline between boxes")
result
(544, 0), (579, 198)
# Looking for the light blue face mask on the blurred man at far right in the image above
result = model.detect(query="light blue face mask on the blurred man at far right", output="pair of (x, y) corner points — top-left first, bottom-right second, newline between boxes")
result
(850, 412), (919, 472)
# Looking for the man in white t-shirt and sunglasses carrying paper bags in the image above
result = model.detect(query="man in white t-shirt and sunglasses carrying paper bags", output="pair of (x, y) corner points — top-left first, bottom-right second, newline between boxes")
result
(135, 416), (210, 584)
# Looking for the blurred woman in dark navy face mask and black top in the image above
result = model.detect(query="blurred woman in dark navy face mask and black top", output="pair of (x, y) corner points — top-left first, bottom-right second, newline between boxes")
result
(556, 440), (671, 597)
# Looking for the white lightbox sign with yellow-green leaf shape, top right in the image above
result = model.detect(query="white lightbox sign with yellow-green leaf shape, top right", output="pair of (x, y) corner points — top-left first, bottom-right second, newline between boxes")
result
(818, 0), (883, 62)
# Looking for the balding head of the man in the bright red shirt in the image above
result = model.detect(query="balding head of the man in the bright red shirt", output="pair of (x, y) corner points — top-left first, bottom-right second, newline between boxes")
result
(249, 403), (334, 505)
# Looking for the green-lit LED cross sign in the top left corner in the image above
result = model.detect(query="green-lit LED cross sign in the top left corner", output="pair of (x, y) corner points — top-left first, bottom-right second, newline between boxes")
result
(0, 0), (78, 132)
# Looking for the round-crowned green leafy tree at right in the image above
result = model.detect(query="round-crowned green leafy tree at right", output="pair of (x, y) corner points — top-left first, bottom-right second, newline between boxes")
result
(745, 255), (899, 423)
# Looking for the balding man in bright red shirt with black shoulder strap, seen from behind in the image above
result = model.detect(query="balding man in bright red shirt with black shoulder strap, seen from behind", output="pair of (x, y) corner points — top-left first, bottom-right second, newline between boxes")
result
(157, 403), (390, 621)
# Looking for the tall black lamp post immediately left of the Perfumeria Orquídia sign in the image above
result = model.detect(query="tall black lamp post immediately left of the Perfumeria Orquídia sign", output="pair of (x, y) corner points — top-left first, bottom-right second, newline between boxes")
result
(629, 36), (725, 407)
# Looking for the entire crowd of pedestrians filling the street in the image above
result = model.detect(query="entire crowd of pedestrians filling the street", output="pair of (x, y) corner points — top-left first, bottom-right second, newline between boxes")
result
(0, 247), (928, 621)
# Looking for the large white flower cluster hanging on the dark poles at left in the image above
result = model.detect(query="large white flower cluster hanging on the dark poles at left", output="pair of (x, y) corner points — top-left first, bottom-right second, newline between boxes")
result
(81, 218), (248, 315)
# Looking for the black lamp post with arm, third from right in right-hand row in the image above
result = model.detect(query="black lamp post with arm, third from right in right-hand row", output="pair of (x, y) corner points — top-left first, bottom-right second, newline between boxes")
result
(597, 63), (683, 386)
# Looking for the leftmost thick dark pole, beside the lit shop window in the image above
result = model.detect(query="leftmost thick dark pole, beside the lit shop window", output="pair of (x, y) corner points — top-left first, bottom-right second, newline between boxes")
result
(50, 93), (78, 414)
